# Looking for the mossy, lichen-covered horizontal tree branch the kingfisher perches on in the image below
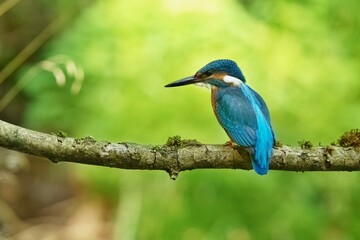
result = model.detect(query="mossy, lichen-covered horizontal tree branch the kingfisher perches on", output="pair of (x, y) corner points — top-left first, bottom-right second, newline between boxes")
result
(0, 120), (360, 179)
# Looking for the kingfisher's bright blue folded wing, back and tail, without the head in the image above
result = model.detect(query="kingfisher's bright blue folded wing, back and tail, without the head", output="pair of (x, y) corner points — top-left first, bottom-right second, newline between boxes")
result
(213, 84), (274, 174)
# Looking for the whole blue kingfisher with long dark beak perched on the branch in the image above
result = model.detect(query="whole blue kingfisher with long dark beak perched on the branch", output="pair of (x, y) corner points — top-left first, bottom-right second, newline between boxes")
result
(165, 59), (275, 175)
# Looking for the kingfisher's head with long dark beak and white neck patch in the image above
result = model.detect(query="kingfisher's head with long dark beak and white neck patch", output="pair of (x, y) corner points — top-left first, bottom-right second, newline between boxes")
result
(165, 59), (246, 88)
